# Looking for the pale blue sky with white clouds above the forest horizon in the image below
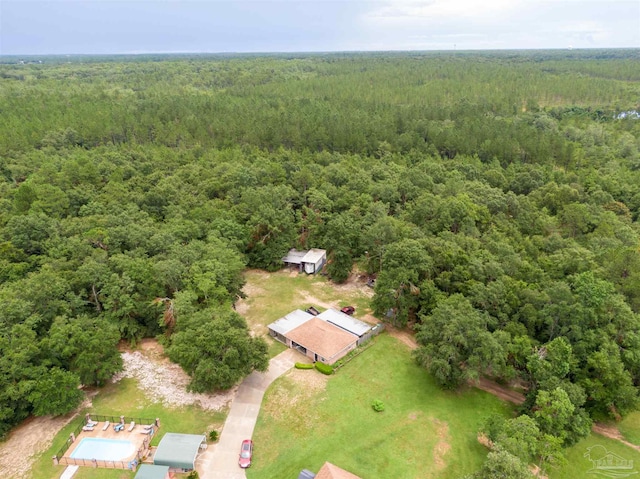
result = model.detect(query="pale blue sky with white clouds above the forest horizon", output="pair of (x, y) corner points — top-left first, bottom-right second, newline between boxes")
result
(0, 0), (640, 55)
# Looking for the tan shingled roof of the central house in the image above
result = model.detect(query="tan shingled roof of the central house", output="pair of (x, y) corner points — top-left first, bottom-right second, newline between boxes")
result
(287, 316), (358, 359)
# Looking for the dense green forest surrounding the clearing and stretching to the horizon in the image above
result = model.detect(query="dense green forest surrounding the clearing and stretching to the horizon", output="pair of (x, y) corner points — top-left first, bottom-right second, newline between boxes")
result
(0, 50), (640, 477)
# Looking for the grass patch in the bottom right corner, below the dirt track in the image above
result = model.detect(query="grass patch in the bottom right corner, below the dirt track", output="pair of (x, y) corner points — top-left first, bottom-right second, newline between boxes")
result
(547, 434), (640, 479)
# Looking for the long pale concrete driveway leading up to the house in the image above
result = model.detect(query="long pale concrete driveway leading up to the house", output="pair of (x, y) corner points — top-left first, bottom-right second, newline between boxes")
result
(196, 349), (302, 479)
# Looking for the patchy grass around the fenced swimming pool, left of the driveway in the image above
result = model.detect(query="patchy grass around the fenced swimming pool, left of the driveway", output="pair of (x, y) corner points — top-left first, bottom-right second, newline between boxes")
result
(31, 379), (226, 479)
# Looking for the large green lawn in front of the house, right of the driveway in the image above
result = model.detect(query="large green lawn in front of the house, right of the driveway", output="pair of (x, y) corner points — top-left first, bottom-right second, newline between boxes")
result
(247, 334), (512, 479)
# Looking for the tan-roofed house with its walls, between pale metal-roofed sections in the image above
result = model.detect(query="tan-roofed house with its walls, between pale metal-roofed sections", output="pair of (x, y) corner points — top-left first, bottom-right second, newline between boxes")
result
(286, 316), (358, 364)
